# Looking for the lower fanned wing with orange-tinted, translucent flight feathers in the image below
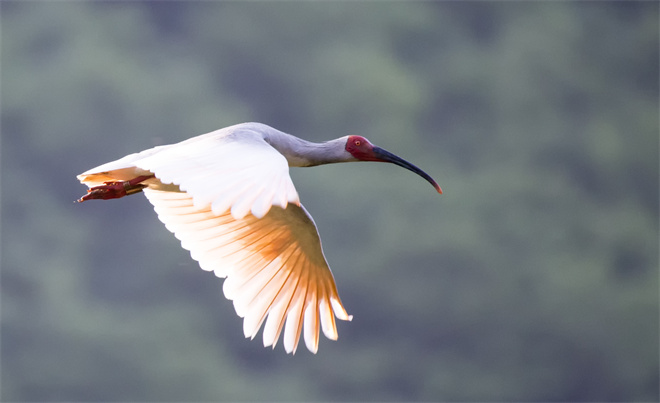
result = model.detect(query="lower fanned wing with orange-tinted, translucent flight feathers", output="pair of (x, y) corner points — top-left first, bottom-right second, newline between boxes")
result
(144, 188), (352, 353)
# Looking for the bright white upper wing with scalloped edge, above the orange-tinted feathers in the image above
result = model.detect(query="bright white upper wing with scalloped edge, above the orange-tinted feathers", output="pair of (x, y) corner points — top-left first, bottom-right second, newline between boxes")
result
(133, 136), (300, 219)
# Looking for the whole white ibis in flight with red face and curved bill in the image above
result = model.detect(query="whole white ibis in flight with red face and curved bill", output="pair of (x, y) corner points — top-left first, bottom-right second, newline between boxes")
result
(77, 123), (442, 353)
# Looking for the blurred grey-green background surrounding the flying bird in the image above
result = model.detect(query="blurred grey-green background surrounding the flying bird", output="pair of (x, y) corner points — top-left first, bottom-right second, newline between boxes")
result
(0, 1), (660, 401)
